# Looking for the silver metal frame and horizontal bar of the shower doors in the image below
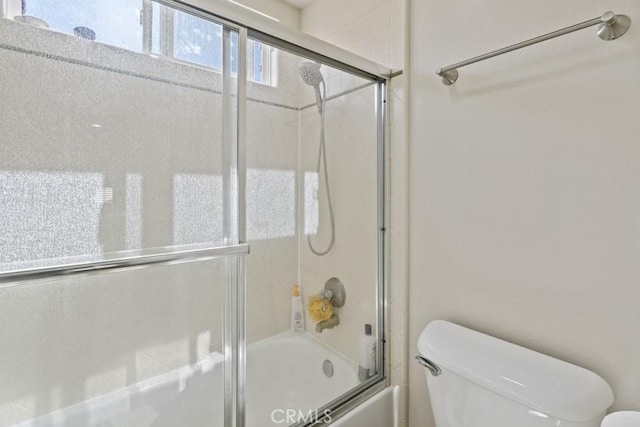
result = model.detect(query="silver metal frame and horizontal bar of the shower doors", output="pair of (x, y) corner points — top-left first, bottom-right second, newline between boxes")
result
(0, 0), (389, 427)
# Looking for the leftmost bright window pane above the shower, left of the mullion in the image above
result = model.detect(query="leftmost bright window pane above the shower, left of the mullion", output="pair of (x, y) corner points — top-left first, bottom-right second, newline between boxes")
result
(25, 0), (142, 52)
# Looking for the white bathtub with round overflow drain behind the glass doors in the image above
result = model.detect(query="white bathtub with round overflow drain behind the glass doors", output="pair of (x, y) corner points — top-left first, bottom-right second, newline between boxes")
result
(19, 333), (372, 427)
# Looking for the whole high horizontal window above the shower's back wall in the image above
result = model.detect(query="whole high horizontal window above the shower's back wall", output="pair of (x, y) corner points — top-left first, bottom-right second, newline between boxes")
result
(7, 0), (277, 86)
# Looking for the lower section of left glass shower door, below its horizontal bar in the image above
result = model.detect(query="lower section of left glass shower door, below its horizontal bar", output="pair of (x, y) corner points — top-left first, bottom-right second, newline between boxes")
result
(0, 258), (235, 427)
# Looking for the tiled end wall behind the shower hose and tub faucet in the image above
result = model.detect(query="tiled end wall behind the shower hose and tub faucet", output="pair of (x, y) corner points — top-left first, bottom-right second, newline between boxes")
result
(300, 80), (377, 362)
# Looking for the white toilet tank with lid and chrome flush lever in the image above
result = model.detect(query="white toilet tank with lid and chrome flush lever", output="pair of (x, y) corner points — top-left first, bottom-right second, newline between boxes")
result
(418, 320), (613, 427)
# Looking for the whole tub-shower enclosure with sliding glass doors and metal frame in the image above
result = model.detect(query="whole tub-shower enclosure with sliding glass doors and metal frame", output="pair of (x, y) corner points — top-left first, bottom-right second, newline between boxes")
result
(0, 0), (388, 427)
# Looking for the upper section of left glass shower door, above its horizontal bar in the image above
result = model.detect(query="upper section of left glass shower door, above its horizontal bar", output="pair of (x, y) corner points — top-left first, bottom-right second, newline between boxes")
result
(0, 0), (237, 271)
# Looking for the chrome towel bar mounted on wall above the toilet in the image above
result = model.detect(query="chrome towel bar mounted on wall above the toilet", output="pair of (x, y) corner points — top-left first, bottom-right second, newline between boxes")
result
(436, 12), (631, 86)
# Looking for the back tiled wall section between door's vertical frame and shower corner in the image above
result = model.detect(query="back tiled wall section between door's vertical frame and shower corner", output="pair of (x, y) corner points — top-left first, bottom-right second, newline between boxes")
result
(247, 51), (300, 343)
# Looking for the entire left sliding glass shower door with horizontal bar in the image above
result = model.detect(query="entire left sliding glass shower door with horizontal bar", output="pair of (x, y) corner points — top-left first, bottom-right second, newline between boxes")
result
(0, 0), (242, 427)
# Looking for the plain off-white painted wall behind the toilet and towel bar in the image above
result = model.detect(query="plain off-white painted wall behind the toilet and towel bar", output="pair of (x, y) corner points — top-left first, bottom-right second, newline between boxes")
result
(410, 0), (640, 427)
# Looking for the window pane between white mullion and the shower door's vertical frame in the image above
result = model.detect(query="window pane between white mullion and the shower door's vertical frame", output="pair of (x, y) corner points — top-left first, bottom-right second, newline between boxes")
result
(175, 11), (222, 69)
